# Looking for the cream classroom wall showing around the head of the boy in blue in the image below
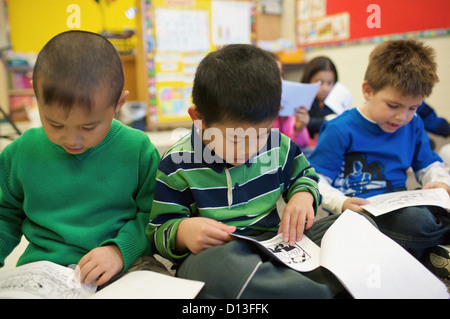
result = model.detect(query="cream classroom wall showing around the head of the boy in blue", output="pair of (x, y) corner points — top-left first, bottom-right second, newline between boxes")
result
(281, 0), (450, 121)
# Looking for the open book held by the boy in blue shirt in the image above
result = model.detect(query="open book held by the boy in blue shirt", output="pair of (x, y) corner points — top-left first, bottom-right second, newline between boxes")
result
(361, 188), (450, 216)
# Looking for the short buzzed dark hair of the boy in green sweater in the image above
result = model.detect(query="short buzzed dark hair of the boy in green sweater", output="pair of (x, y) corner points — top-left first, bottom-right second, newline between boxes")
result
(33, 30), (124, 112)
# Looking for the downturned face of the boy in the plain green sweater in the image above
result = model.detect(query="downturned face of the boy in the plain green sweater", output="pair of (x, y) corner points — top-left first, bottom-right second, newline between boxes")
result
(39, 91), (126, 154)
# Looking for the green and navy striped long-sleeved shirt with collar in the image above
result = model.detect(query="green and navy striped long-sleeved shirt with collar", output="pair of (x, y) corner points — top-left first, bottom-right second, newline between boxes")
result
(147, 130), (321, 263)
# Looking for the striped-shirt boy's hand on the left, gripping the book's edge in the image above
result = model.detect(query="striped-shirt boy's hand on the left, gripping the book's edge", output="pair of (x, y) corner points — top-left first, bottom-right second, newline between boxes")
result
(176, 217), (236, 254)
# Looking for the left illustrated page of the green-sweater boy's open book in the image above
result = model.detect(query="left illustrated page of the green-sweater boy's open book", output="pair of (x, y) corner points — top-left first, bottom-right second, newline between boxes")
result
(0, 261), (97, 299)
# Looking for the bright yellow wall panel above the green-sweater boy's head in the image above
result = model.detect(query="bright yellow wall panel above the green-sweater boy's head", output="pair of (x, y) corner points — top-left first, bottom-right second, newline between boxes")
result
(7, 0), (136, 52)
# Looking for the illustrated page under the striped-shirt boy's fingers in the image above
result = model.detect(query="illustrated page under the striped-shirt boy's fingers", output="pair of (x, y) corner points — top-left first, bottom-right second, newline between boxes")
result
(233, 234), (320, 272)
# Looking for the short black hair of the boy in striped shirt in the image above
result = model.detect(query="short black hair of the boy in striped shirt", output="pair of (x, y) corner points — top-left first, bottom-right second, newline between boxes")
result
(192, 44), (281, 125)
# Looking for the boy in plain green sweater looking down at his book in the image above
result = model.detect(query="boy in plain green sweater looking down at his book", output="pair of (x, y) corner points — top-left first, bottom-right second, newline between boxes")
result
(0, 31), (160, 286)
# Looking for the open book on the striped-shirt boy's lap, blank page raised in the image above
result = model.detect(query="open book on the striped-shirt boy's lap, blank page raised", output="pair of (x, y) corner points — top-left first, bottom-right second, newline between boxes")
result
(234, 210), (449, 299)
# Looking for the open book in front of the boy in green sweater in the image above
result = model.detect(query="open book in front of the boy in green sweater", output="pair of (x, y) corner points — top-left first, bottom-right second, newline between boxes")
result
(0, 261), (204, 299)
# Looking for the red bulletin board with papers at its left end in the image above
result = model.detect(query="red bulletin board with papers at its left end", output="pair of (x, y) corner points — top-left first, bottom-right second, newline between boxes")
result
(297, 0), (450, 47)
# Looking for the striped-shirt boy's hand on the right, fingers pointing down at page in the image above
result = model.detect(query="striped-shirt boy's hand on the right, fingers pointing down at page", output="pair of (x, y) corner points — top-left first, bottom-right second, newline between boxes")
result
(278, 192), (314, 246)
